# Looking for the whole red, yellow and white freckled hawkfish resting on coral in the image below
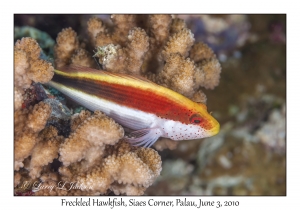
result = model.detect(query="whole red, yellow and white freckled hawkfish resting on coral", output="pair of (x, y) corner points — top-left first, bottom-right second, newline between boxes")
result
(48, 65), (220, 147)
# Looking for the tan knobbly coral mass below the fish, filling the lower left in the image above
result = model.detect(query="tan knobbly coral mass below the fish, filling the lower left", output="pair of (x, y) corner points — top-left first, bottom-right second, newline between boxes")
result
(15, 108), (161, 195)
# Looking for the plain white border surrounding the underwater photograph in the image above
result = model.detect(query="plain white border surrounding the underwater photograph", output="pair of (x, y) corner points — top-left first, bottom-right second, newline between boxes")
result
(4, 0), (300, 210)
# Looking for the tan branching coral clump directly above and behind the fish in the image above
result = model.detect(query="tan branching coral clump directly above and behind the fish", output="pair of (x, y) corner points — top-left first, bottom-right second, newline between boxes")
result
(88, 15), (221, 102)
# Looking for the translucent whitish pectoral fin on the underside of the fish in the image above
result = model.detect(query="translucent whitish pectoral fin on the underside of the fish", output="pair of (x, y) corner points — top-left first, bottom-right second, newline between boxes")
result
(125, 128), (163, 147)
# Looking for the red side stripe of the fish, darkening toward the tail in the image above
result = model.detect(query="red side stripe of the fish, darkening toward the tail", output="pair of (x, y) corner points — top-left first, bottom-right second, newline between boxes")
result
(52, 74), (200, 124)
